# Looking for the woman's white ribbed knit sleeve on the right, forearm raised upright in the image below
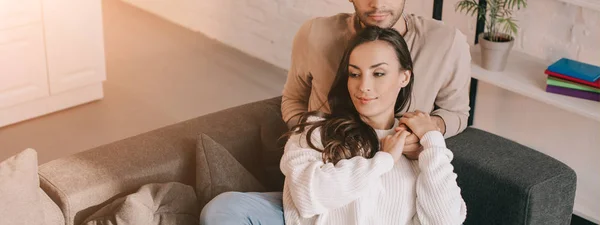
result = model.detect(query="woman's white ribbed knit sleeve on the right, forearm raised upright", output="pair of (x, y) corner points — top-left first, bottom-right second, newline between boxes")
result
(415, 131), (467, 225)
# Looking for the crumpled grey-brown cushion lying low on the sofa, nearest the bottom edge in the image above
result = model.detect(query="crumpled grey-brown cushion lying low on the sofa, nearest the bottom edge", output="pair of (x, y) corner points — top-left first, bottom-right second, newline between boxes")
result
(83, 182), (199, 225)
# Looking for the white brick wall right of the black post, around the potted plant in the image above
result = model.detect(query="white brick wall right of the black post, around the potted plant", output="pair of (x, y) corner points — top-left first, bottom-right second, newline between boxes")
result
(443, 0), (600, 65)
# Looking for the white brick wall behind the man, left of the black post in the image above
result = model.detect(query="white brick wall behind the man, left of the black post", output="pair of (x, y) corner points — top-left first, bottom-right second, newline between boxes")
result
(118, 0), (433, 69)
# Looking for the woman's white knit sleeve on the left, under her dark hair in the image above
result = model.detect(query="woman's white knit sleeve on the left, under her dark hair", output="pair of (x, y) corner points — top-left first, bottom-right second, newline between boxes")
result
(280, 129), (394, 218)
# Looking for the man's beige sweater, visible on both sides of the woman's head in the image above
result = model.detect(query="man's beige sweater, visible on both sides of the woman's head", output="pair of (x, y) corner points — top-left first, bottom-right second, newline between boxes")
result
(281, 13), (471, 137)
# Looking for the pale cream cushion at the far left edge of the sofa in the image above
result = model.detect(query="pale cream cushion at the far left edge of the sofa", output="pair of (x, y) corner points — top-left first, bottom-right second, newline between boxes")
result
(0, 149), (44, 225)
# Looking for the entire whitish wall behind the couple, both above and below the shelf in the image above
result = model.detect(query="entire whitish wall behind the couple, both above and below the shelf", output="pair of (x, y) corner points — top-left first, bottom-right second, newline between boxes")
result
(118, 0), (600, 222)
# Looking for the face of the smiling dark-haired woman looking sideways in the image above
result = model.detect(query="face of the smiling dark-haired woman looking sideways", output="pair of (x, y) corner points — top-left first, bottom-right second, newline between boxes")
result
(348, 40), (411, 120)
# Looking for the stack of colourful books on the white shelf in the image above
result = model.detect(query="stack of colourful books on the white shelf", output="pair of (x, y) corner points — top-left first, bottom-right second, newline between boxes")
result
(544, 58), (600, 102)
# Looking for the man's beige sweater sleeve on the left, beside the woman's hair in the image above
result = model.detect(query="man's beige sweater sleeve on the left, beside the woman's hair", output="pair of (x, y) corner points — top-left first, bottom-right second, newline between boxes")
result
(281, 20), (313, 125)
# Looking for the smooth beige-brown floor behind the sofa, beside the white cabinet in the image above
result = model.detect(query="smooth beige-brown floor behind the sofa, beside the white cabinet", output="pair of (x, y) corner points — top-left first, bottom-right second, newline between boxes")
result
(0, 0), (286, 164)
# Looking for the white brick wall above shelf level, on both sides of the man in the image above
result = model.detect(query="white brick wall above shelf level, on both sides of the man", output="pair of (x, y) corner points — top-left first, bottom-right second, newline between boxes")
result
(124, 0), (600, 68)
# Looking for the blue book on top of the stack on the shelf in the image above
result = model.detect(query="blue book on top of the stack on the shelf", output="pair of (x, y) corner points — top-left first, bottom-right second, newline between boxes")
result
(548, 58), (600, 82)
